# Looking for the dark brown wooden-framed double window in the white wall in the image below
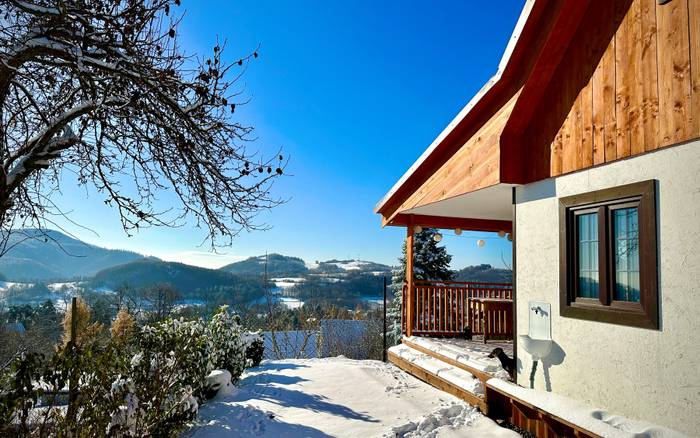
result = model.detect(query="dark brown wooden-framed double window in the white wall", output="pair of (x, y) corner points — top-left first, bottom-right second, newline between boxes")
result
(560, 181), (659, 329)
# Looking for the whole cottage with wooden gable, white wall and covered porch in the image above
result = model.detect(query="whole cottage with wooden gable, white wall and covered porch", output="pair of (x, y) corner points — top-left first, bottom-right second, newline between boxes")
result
(376, 0), (700, 436)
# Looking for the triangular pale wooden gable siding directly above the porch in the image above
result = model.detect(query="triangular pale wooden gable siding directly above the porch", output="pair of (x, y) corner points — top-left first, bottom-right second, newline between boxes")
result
(397, 91), (519, 212)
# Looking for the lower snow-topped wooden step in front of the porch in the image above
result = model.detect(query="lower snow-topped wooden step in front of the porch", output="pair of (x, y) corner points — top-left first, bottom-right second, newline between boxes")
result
(388, 345), (488, 414)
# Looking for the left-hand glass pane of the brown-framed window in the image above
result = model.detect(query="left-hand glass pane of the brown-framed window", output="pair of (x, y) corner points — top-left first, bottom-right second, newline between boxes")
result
(576, 213), (598, 298)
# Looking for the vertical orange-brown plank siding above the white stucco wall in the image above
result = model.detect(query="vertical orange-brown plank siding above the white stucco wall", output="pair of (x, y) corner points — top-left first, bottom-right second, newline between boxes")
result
(520, 0), (700, 183)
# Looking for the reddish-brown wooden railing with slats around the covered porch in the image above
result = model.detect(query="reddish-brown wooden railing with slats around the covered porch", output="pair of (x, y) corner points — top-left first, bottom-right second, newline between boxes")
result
(401, 281), (513, 340)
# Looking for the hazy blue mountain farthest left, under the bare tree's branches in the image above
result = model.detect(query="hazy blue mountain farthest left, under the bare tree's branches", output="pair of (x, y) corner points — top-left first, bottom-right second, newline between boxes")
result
(0, 229), (144, 281)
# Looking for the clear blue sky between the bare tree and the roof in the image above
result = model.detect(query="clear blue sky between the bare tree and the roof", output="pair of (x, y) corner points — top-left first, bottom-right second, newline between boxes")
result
(52, 0), (523, 268)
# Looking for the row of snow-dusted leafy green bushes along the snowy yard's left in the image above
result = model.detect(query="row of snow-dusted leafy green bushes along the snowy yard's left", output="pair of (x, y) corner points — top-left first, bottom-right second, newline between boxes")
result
(0, 307), (262, 437)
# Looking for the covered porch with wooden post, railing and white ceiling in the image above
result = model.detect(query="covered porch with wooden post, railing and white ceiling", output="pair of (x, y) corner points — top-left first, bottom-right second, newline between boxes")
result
(384, 184), (515, 343)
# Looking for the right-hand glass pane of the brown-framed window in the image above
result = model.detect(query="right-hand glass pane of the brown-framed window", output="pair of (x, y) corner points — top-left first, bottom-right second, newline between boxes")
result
(613, 207), (639, 302)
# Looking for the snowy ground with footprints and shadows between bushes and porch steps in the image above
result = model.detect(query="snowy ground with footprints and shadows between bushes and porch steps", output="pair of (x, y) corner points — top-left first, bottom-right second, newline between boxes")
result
(183, 357), (519, 438)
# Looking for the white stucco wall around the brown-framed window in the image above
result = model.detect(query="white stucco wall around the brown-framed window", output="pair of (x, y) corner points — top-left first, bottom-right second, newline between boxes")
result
(516, 141), (700, 436)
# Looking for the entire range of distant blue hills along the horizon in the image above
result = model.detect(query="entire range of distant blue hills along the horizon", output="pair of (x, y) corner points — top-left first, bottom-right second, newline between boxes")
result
(0, 229), (512, 300)
